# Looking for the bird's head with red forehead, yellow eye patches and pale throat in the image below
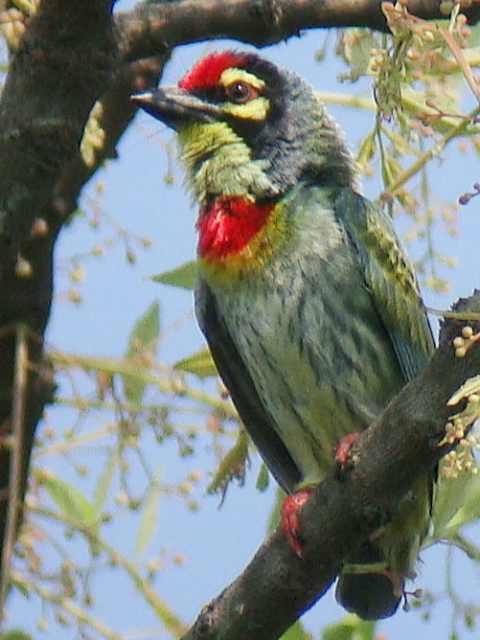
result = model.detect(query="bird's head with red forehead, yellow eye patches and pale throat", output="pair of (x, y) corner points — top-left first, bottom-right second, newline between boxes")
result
(133, 51), (353, 203)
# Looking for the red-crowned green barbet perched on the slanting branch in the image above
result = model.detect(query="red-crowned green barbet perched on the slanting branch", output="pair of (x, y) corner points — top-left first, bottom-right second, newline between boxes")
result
(133, 50), (434, 620)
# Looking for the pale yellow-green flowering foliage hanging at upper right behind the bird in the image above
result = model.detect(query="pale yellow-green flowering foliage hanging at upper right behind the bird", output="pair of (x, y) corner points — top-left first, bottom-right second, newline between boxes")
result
(334, 3), (480, 292)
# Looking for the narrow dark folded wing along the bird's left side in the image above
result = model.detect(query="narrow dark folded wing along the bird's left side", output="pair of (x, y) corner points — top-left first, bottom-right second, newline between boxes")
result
(195, 280), (302, 493)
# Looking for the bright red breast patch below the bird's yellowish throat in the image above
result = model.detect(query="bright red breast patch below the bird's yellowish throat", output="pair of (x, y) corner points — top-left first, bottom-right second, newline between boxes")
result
(197, 196), (275, 261)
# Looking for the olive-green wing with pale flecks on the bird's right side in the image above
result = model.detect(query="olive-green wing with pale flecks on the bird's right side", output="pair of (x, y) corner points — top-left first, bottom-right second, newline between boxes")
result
(335, 190), (435, 380)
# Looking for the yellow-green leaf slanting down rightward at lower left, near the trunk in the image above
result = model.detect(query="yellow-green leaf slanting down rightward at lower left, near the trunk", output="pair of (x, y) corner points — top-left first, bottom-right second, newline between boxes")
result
(37, 470), (99, 532)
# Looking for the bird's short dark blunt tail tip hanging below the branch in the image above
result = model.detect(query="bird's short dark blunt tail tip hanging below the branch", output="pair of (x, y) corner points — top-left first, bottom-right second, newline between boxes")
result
(335, 542), (403, 620)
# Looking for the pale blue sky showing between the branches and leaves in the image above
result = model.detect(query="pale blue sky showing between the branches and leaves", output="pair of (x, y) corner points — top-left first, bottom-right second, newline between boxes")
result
(9, 3), (480, 640)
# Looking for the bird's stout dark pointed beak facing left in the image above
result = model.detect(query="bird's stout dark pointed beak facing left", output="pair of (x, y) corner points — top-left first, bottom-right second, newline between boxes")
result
(131, 87), (222, 129)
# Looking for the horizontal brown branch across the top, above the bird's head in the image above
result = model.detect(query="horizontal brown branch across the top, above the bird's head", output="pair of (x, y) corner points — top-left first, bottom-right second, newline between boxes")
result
(116, 0), (480, 60)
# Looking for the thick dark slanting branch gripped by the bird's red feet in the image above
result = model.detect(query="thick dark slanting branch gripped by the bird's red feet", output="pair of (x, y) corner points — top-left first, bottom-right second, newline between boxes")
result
(183, 292), (480, 640)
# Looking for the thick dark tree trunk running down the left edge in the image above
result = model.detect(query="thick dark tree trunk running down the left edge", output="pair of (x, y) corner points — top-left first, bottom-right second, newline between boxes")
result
(0, 0), (116, 580)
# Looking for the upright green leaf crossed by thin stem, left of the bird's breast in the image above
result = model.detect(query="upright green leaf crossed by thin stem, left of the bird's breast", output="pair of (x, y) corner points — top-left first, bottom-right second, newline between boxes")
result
(123, 302), (160, 404)
